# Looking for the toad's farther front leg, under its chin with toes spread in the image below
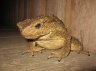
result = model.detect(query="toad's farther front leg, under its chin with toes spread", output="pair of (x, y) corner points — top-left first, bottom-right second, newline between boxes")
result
(23, 42), (45, 56)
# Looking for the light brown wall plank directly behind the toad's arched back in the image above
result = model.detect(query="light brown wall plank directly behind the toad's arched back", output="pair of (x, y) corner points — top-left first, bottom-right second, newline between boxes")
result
(47, 0), (66, 22)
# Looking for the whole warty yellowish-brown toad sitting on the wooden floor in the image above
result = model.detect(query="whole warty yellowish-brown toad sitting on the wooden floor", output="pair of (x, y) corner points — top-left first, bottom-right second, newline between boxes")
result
(17, 16), (89, 61)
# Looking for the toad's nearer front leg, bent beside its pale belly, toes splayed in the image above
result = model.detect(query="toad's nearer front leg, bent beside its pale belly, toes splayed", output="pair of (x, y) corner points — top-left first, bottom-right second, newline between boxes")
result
(48, 36), (70, 62)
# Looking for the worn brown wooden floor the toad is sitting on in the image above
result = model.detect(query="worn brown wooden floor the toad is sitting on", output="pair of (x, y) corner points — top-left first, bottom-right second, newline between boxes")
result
(0, 29), (96, 71)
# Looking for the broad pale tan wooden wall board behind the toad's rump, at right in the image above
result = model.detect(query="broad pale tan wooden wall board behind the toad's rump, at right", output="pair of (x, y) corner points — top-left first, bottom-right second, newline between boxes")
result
(70, 0), (96, 53)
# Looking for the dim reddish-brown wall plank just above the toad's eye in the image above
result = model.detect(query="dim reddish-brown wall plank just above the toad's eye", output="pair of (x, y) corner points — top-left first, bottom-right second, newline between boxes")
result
(27, 0), (46, 18)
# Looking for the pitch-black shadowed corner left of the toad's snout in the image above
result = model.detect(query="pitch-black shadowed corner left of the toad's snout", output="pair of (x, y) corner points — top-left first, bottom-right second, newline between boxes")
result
(0, 0), (16, 28)
